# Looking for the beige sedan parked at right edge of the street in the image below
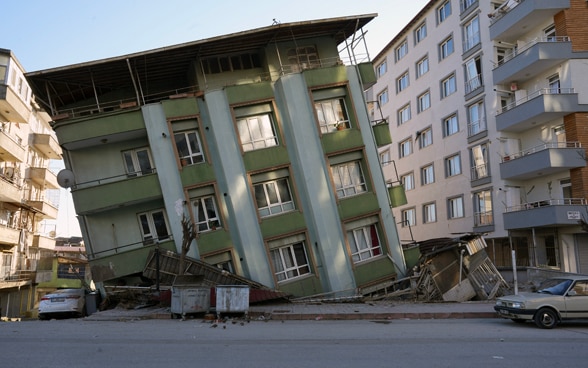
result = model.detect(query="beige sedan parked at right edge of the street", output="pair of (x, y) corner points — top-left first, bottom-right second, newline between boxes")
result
(494, 275), (588, 328)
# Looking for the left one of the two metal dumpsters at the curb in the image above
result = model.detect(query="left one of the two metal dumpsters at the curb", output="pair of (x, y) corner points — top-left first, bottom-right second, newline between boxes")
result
(170, 275), (210, 319)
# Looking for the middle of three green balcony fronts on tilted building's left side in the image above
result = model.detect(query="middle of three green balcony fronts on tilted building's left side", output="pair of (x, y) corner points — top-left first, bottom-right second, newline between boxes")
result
(71, 173), (162, 215)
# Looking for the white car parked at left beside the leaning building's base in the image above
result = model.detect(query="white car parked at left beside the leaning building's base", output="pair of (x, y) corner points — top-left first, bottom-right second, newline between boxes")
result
(39, 289), (86, 320)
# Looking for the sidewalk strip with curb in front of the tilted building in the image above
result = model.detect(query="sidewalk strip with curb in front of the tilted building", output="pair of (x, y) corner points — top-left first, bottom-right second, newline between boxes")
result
(85, 301), (497, 321)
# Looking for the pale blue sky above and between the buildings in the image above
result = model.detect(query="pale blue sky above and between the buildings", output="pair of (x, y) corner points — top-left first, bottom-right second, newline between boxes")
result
(0, 0), (429, 237)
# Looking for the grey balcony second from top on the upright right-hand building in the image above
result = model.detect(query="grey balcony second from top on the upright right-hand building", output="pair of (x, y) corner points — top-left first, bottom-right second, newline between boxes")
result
(492, 36), (574, 84)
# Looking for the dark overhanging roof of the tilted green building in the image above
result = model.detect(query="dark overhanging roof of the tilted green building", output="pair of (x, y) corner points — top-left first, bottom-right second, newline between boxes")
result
(26, 14), (377, 111)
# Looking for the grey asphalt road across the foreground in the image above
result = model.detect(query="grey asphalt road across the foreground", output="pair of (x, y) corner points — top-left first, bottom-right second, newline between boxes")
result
(0, 319), (588, 368)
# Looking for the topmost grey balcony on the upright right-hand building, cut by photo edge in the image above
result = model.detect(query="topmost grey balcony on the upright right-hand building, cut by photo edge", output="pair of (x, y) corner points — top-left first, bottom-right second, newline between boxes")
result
(488, 0), (570, 42)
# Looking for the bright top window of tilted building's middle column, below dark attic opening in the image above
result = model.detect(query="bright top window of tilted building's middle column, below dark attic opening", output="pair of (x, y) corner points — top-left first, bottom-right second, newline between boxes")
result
(237, 114), (278, 152)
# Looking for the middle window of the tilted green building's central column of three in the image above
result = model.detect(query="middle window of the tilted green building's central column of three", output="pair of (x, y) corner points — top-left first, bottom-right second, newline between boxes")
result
(253, 178), (294, 217)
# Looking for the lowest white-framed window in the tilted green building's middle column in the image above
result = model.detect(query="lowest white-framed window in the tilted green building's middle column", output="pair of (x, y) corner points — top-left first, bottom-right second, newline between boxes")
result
(270, 241), (310, 282)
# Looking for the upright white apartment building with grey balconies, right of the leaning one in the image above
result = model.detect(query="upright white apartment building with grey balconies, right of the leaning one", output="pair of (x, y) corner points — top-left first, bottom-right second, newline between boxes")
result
(367, 0), (588, 273)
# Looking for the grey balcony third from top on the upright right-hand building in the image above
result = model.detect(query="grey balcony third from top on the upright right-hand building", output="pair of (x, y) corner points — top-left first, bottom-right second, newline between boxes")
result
(496, 88), (588, 132)
